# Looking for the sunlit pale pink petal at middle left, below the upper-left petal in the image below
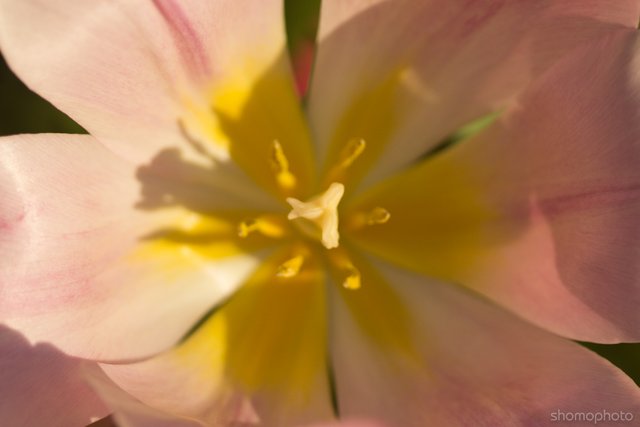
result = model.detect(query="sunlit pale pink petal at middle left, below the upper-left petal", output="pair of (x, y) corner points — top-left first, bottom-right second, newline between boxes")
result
(0, 135), (268, 360)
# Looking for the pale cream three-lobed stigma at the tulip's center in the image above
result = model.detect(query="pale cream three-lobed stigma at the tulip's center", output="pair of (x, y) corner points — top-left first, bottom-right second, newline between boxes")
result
(287, 182), (344, 249)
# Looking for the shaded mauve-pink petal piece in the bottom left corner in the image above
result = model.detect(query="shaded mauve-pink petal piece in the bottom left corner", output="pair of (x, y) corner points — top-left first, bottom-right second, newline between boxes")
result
(0, 325), (109, 427)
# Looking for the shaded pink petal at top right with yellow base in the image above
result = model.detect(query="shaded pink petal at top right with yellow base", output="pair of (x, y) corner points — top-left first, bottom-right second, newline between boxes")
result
(309, 0), (640, 187)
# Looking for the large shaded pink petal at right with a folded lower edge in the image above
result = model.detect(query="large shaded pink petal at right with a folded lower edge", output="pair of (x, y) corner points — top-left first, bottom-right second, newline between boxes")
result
(357, 30), (640, 343)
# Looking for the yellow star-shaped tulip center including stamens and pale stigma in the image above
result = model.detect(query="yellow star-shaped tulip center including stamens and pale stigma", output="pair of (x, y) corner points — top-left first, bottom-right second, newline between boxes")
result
(149, 61), (466, 405)
